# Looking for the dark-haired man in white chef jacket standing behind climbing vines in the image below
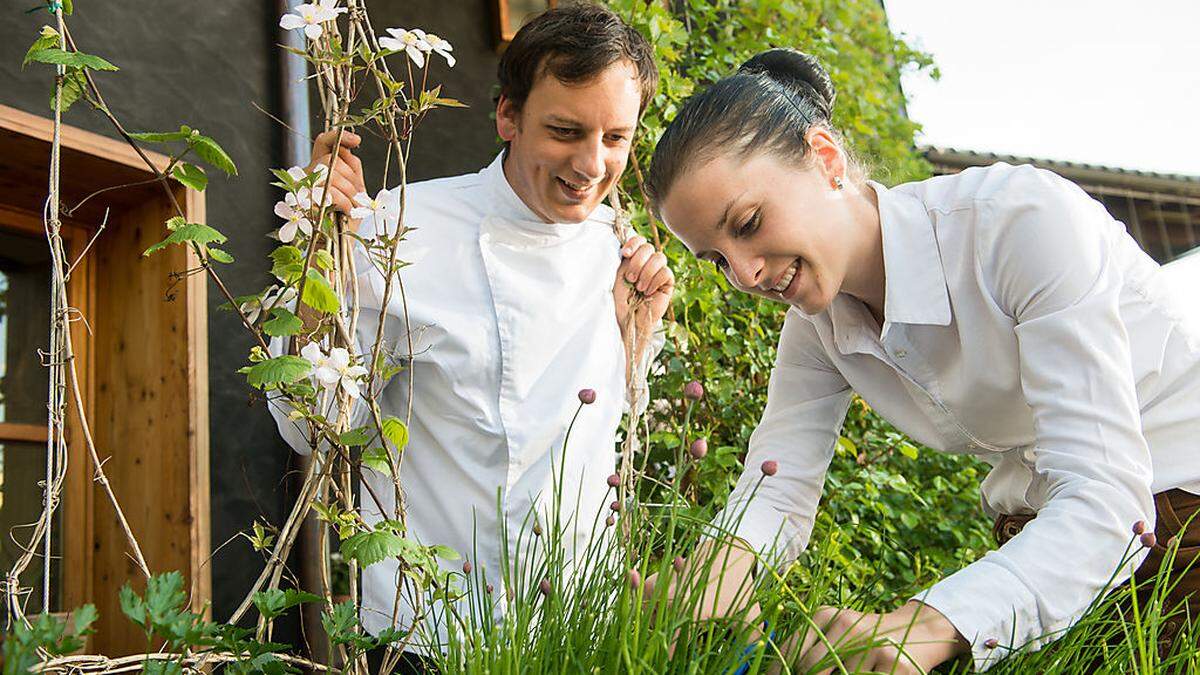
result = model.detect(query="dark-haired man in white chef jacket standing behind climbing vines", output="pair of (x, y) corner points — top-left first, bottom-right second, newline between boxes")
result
(272, 4), (674, 667)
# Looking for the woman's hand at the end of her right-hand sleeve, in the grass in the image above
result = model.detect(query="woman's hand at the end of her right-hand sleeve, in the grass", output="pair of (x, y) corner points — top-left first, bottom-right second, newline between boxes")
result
(770, 601), (968, 675)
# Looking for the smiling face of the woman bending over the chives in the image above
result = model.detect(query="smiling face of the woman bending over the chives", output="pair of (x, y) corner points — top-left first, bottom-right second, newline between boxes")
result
(659, 153), (856, 313)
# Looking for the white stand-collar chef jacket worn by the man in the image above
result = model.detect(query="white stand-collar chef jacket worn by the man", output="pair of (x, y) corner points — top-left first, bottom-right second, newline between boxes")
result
(272, 154), (643, 651)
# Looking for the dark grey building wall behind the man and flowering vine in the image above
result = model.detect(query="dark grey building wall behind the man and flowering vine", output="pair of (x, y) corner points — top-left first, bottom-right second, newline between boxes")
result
(0, 0), (498, 641)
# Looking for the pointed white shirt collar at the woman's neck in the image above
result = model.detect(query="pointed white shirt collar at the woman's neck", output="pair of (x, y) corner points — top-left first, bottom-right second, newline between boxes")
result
(868, 180), (950, 338)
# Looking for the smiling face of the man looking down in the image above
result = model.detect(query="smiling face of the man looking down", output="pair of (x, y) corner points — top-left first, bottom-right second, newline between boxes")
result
(496, 61), (641, 222)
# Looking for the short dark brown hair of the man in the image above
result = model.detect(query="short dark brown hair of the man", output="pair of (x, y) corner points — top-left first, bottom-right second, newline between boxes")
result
(497, 2), (659, 112)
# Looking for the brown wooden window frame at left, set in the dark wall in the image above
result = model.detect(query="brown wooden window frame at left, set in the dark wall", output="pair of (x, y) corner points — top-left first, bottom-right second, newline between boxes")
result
(0, 104), (212, 656)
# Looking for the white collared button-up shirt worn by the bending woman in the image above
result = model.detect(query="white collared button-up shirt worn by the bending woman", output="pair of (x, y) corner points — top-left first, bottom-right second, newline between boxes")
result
(718, 163), (1200, 669)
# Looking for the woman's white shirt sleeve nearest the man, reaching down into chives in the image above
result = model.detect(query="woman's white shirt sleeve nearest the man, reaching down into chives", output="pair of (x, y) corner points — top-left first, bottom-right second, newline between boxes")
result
(713, 311), (851, 563)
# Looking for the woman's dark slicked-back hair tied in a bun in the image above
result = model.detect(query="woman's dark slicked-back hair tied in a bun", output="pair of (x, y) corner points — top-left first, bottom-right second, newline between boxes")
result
(648, 49), (854, 203)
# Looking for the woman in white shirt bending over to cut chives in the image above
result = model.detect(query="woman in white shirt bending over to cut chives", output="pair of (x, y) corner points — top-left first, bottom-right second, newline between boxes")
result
(650, 49), (1200, 673)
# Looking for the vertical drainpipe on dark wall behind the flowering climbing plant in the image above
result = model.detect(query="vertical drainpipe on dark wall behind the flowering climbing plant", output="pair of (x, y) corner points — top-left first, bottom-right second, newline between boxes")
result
(276, 0), (330, 663)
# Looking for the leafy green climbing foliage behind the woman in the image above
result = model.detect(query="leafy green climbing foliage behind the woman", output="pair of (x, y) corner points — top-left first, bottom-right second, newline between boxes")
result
(607, 0), (991, 609)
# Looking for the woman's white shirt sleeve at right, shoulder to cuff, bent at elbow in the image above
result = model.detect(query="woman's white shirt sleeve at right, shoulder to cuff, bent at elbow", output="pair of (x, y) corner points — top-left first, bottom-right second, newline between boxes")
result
(914, 168), (1154, 670)
